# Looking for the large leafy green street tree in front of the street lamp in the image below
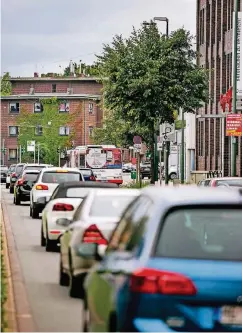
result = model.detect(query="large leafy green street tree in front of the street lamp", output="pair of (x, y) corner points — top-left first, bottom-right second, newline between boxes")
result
(97, 22), (208, 182)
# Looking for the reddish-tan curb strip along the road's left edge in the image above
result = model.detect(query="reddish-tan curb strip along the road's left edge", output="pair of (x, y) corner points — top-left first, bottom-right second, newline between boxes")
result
(1, 200), (38, 332)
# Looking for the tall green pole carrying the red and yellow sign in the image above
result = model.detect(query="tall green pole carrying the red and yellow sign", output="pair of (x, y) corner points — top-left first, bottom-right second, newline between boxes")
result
(231, 0), (239, 177)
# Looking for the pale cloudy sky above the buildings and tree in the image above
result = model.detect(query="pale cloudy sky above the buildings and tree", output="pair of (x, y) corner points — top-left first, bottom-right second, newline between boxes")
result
(1, 0), (196, 77)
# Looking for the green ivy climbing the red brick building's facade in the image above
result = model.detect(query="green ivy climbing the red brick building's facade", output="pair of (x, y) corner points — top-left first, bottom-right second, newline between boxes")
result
(17, 98), (82, 165)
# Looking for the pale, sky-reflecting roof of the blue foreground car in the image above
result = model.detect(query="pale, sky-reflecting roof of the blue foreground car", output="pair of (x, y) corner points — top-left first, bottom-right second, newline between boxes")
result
(142, 186), (242, 205)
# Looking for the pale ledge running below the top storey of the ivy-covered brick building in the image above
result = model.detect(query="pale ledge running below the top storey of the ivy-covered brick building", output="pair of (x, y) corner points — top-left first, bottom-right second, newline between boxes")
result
(1, 93), (101, 101)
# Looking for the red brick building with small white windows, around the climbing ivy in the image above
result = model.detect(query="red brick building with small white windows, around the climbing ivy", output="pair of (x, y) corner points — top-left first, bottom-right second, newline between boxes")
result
(1, 73), (102, 165)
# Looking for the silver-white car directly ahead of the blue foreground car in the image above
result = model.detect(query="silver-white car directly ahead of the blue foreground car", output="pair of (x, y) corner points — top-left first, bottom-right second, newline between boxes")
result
(59, 189), (140, 297)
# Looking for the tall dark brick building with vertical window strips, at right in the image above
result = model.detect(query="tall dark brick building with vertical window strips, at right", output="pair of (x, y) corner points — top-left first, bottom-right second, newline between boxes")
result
(196, 0), (242, 177)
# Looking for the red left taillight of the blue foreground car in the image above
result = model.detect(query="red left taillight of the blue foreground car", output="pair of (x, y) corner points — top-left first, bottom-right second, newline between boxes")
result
(130, 268), (197, 296)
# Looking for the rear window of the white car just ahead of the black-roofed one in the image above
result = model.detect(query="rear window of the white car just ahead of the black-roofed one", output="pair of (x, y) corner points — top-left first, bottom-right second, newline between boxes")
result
(42, 171), (82, 184)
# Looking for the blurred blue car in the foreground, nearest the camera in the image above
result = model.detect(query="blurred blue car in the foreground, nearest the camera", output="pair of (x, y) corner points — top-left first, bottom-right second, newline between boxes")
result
(77, 187), (242, 332)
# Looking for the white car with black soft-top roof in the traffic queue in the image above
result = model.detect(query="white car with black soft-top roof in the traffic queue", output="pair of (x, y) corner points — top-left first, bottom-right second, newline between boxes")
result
(41, 182), (117, 252)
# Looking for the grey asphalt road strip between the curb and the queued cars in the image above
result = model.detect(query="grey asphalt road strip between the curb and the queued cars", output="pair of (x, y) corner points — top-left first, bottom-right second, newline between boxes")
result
(1, 185), (82, 332)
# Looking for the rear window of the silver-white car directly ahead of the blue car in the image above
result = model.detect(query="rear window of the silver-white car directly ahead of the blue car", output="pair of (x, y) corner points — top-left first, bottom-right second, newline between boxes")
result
(90, 195), (134, 217)
